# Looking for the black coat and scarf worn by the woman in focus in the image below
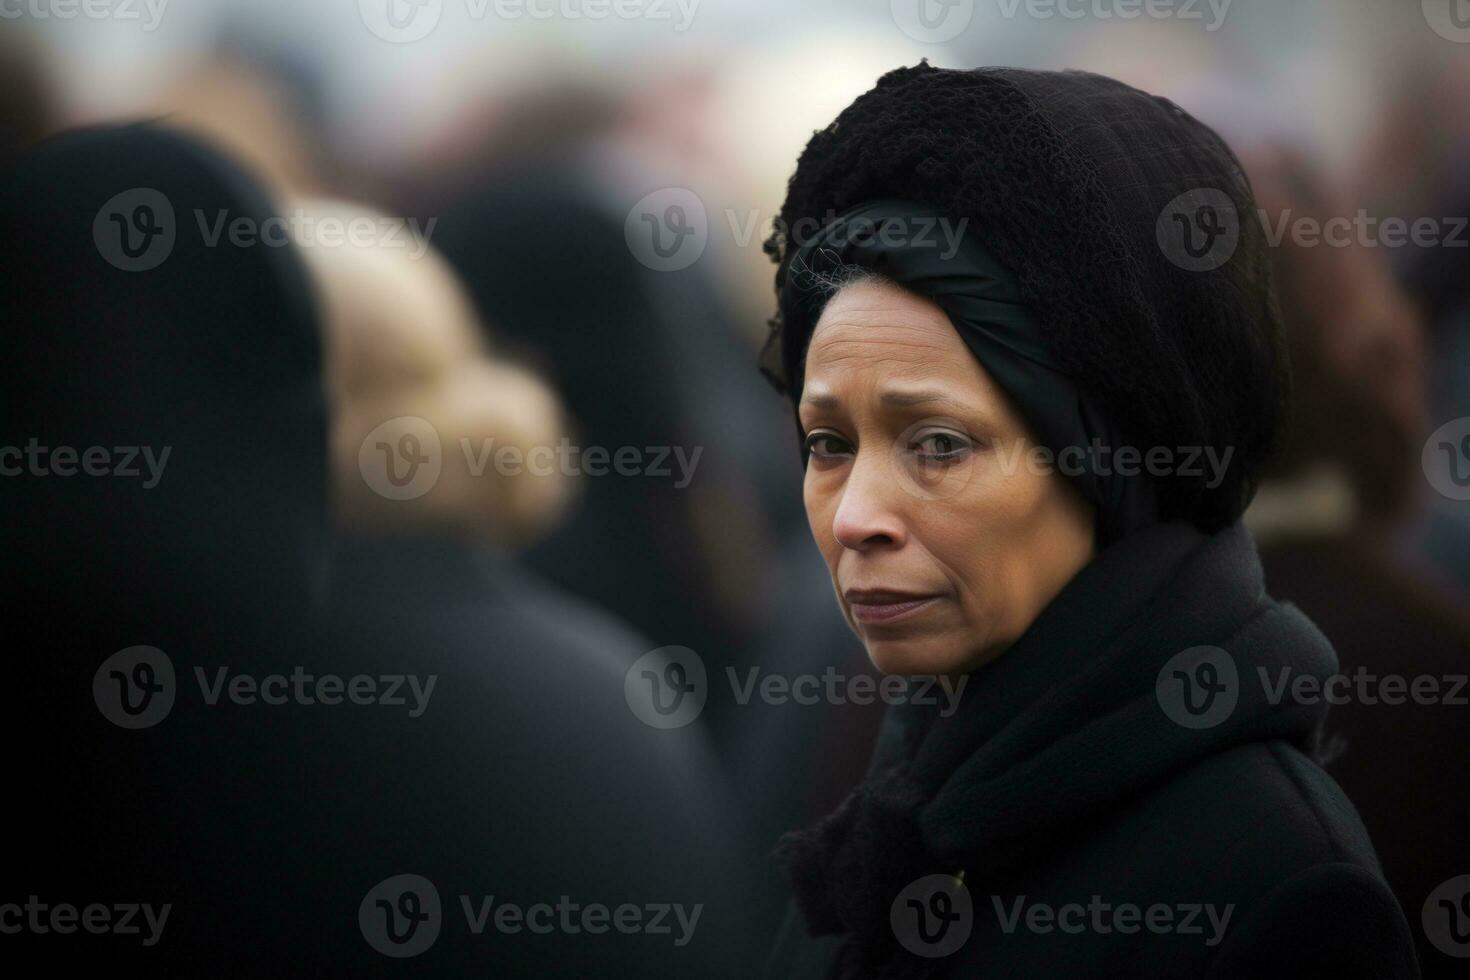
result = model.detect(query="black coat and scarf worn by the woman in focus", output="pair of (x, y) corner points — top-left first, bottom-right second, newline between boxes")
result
(769, 525), (1417, 980)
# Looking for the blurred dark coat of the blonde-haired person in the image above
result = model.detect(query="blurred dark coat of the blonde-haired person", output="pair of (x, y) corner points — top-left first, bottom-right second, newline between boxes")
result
(312, 539), (764, 980)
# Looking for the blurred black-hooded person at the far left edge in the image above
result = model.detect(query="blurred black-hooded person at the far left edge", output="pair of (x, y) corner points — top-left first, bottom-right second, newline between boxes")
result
(0, 126), (336, 976)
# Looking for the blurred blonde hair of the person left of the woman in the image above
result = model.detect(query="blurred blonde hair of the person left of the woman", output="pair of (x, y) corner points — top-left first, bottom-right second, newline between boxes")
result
(287, 191), (573, 545)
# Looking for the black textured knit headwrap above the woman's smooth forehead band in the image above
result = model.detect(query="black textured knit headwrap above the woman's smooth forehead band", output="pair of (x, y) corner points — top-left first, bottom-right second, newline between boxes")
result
(761, 63), (1289, 530)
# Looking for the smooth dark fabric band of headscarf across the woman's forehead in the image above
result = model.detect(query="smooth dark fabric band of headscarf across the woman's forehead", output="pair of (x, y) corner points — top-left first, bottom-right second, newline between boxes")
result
(779, 200), (1157, 547)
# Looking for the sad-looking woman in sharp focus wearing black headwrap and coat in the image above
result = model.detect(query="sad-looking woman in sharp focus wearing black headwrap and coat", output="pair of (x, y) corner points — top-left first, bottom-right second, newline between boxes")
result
(763, 65), (1417, 979)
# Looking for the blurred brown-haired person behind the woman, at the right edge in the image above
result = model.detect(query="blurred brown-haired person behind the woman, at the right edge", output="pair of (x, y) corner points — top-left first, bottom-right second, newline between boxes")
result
(1245, 147), (1470, 977)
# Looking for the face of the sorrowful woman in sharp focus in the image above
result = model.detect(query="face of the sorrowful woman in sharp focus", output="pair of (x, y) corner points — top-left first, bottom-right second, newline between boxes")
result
(800, 281), (1094, 674)
